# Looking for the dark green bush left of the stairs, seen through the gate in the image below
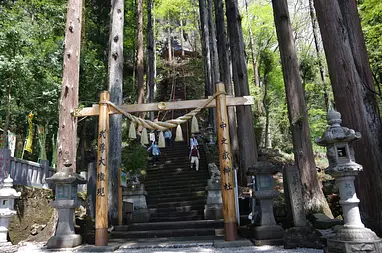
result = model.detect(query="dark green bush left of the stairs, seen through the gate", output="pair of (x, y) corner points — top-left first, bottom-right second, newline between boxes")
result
(122, 140), (148, 172)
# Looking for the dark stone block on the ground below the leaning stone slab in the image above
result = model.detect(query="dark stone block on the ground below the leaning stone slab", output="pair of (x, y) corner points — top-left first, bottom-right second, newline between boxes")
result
(284, 226), (325, 249)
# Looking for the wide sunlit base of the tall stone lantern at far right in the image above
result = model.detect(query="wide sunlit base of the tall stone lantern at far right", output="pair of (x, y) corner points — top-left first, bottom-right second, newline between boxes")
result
(325, 228), (382, 253)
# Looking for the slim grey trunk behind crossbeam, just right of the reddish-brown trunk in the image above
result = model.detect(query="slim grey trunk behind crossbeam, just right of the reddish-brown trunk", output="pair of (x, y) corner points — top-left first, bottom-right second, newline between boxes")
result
(147, 0), (156, 120)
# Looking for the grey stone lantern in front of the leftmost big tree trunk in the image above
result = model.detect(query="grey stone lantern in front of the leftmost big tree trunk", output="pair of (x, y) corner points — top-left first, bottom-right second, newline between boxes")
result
(46, 161), (87, 248)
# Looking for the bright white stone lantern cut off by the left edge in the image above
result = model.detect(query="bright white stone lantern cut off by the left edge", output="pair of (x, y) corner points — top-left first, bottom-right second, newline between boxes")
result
(0, 175), (21, 246)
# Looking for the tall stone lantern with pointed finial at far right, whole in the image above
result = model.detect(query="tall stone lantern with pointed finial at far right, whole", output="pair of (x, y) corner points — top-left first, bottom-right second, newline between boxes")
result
(315, 108), (382, 253)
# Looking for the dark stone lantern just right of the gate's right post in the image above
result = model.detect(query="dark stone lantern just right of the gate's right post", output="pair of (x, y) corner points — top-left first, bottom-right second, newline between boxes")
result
(247, 161), (284, 245)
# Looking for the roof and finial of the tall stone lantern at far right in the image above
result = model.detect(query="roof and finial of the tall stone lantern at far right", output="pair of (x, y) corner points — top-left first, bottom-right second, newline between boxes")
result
(315, 107), (361, 146)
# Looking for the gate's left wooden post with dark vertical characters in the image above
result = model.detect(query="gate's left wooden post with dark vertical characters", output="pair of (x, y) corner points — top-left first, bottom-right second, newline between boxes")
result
(95, 91), (110, 246)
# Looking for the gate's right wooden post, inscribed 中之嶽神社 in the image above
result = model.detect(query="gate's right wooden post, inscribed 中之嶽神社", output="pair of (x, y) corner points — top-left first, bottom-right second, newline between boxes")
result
(216, 83), (237, 241)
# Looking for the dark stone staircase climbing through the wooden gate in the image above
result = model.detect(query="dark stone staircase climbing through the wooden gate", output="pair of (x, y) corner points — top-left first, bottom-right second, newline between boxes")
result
(110, 142), (223, 239)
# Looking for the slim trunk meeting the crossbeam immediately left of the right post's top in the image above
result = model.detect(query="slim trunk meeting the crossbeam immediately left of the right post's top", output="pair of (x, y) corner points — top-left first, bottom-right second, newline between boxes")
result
(207, 0), (216, 132)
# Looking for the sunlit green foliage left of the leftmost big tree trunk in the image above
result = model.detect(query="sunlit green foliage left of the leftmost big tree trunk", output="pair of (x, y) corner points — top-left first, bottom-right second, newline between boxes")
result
(0, 0), (66, 160)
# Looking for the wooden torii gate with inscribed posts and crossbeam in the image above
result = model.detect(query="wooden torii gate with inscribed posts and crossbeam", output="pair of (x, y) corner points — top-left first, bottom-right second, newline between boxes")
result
(73, 83), (253, 246)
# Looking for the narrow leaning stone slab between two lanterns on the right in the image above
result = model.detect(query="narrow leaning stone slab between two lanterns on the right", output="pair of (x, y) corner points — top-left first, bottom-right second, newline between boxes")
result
(285, 166), (307, 227)
